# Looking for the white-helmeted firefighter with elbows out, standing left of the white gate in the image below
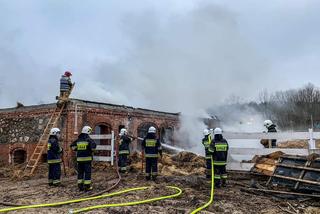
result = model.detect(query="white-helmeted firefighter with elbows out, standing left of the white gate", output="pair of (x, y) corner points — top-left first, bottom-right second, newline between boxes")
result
(70, 126), (97, 191)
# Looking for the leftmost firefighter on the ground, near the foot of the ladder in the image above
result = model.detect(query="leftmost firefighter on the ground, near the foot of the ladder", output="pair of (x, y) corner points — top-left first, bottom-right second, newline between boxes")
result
(47, 128), (62, 186)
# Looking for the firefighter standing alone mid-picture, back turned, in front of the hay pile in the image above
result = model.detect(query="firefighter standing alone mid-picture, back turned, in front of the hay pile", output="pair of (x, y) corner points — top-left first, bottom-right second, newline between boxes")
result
(142, 126), (162, 181)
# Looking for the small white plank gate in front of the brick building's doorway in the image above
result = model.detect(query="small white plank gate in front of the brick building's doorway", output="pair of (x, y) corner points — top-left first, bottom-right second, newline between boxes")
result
(90, 131), (115, 166)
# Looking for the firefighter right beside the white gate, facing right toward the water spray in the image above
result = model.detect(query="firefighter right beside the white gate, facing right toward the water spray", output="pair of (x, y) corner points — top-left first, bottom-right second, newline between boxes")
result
(118, 129), (132, 173)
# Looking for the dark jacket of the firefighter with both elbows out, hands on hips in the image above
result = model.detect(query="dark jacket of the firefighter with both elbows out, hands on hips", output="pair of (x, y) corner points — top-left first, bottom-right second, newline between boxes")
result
(70, 133), (97, 162)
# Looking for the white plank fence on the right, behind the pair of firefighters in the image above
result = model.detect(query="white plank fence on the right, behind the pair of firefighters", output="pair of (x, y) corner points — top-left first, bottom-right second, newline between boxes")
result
(224, 129), (320, 171)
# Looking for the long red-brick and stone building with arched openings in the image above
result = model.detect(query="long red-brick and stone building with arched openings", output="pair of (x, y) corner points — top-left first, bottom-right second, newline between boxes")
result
(0, 99), (179, 164)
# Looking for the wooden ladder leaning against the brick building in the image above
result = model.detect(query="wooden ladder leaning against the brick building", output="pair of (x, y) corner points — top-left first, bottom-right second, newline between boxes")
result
(22, 85), (74, 177)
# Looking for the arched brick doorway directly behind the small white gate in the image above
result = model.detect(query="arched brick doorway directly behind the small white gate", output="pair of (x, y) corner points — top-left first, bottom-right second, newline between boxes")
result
(94, 123), (112, 156)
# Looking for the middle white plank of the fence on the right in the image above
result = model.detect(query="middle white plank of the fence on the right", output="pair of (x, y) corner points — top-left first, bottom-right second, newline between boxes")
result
(229, 147), (309, 156)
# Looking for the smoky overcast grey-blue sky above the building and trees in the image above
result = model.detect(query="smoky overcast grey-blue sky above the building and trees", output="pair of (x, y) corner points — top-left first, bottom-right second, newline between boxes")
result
(0, 0), (320, 111)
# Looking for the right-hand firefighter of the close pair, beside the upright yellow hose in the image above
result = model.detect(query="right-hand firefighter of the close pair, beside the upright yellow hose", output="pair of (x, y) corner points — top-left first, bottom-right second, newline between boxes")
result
(209, 128), (229, 188)
